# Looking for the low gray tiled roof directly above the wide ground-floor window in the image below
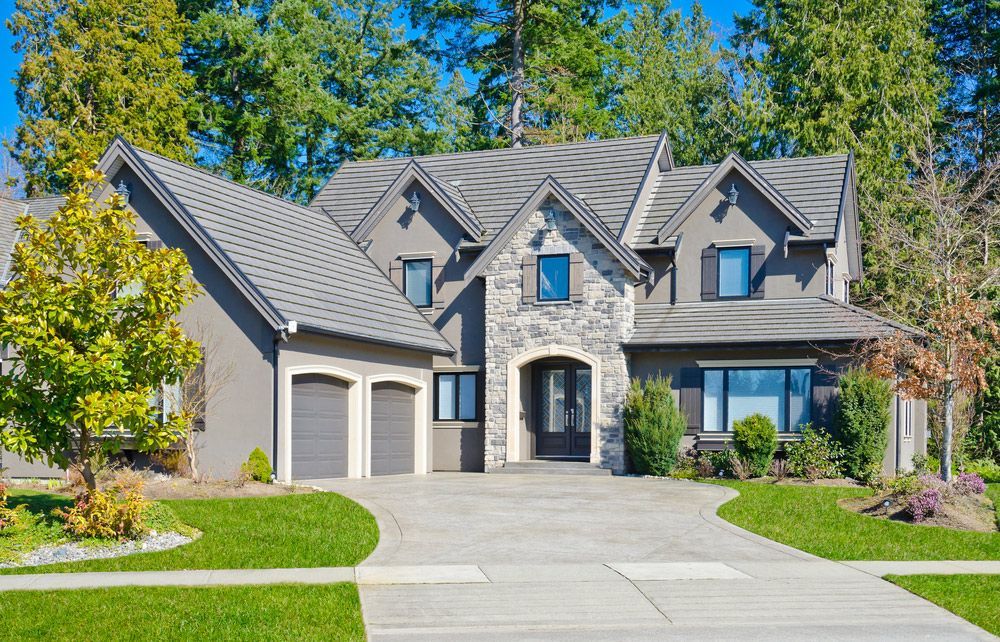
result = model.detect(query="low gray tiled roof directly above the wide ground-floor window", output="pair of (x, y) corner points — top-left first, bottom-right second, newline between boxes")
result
(628, 296), (916, 350)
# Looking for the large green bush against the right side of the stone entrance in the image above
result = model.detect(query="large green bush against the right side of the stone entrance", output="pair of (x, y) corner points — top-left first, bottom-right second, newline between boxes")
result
(624, 375), (687, 477)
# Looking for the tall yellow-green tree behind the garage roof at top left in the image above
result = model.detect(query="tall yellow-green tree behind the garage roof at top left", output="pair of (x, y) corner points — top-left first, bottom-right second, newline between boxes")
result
(7, 0), (192, 196)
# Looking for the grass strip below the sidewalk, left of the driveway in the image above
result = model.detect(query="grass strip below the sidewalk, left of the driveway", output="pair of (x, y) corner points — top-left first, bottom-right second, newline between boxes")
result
(0, 584), (365, 641)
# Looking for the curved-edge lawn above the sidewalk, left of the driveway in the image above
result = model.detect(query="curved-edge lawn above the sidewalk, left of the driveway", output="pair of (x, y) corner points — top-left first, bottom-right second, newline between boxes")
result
(0, 489), (378, 574)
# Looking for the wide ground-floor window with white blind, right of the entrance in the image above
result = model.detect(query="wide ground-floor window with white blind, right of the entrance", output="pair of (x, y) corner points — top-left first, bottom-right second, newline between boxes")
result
(702, 368), (812, 432)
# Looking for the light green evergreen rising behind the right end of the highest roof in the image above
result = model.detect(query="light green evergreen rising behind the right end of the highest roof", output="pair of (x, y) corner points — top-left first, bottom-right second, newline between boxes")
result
(610, 0), (735, 165)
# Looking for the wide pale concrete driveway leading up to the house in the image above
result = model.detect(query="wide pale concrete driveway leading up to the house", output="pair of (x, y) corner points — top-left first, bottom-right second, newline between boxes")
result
(311, 473), (994, 642)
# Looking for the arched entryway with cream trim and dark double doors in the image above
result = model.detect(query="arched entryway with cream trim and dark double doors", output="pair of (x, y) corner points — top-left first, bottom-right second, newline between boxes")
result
(506, 345), (601, 463)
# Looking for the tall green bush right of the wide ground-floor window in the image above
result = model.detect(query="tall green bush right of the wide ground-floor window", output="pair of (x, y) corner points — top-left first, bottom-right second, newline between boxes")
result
(834, 368), (892, 482)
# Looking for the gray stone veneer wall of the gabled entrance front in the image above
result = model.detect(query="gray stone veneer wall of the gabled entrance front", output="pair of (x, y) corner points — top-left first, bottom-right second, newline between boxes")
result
(483, 203), (635, 472)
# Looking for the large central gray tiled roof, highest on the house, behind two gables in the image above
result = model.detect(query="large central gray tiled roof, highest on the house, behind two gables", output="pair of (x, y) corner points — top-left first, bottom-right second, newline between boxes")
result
(311, 136), (660, 240)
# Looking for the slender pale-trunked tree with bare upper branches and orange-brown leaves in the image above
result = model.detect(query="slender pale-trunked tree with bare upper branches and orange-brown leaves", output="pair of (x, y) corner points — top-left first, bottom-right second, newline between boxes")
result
(871, 121), (1000, 480)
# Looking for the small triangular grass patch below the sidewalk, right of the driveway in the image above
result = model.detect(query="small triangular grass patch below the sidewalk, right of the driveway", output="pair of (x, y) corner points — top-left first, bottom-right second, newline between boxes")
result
(885, 575), (1000, 635)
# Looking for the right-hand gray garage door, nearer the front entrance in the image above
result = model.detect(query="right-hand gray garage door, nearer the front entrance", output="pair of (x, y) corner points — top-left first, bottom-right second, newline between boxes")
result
(371, 382), (416, 475)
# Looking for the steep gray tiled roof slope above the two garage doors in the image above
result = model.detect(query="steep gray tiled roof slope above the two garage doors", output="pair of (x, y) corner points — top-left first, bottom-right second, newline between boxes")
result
(97, 141), (454, 354)
